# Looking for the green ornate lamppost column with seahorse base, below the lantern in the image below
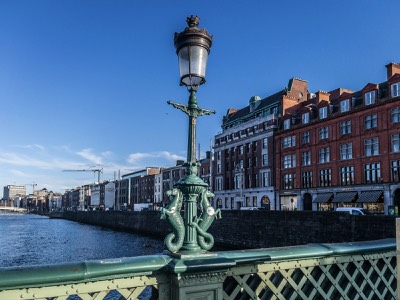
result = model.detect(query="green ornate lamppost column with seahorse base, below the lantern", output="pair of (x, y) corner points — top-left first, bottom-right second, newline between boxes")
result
(160, 89), (221, 253)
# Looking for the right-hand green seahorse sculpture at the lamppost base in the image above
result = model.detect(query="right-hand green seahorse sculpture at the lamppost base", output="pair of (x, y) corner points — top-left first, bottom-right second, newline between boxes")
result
(189, 190), (221, 250)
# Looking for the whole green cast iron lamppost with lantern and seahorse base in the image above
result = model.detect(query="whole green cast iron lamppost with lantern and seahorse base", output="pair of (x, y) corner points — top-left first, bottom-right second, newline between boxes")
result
(160, 16), (221, 254)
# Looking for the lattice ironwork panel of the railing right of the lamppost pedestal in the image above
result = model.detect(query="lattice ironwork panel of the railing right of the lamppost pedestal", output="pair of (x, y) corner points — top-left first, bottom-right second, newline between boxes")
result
(223, 252), (397, 300)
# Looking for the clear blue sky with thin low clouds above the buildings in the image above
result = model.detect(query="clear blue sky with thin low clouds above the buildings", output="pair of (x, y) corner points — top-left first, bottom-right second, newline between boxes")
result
(0, 0), (400, 193)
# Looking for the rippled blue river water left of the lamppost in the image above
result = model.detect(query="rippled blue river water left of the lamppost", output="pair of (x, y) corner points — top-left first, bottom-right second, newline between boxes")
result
(0, 214), (164, 267)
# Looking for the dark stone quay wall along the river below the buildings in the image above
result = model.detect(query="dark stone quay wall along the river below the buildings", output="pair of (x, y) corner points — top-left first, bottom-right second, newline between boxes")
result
(59, 210), (396, 249)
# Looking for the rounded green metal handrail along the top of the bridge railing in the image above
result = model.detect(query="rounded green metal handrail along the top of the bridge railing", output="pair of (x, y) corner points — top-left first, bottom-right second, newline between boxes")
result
(0, 238), (396, 296)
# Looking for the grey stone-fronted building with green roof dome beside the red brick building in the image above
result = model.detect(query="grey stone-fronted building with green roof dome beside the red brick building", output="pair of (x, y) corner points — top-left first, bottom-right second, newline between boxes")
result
(213, 78), (308, 210)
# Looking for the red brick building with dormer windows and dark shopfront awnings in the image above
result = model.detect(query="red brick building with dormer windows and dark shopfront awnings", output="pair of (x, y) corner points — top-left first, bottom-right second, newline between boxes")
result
(275, 63), (400, 213)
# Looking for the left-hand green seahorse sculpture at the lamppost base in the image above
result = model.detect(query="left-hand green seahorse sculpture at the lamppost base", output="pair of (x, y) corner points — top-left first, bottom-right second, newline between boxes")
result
(159, 188), (185, 253)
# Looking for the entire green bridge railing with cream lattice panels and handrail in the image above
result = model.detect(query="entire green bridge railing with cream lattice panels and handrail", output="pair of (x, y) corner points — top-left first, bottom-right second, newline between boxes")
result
(0, 239), (397, 300)
